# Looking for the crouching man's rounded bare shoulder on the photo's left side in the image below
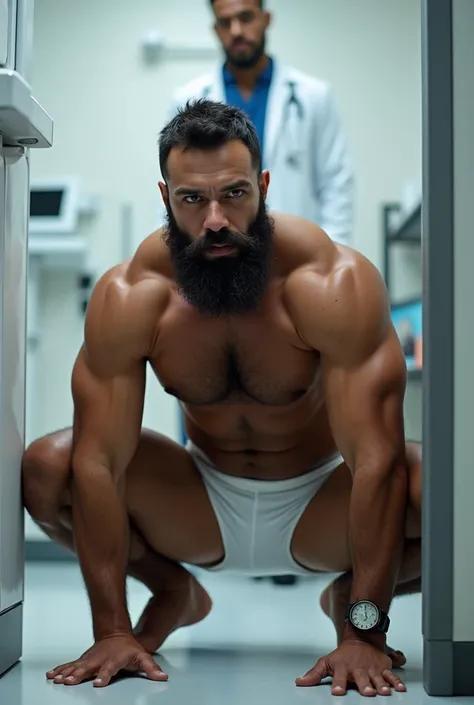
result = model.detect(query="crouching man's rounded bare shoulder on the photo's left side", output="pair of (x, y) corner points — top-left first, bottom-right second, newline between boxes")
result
(85, 233), (171, 374)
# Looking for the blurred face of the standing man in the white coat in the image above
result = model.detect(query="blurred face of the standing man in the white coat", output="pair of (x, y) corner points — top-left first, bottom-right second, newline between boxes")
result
(214, 0), (271, 68)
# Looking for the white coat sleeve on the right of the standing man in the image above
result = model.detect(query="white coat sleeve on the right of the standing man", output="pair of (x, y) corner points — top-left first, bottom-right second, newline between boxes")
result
(312, 87), (354, 245)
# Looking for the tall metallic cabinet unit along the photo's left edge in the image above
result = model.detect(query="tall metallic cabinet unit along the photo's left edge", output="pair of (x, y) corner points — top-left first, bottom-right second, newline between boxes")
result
(0, 0), (53, 673)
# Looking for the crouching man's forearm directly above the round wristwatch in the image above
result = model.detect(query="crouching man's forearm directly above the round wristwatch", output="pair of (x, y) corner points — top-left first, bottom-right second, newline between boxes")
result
(348, 464), (407, 632)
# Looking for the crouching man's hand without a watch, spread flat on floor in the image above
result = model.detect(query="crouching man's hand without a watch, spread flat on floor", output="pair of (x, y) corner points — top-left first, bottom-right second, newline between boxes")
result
(46, 635), (168, 687)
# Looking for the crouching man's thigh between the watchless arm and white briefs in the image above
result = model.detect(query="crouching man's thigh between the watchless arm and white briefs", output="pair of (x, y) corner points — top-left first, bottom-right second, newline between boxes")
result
(124, 430), (224, 566)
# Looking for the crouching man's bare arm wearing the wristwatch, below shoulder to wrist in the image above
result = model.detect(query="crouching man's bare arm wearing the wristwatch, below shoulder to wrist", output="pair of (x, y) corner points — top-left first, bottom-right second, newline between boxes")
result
(322, 302), (408, 644)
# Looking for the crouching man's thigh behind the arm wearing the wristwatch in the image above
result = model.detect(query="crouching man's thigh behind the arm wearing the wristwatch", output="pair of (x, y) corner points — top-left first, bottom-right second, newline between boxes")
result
(291, 443), (422, 573)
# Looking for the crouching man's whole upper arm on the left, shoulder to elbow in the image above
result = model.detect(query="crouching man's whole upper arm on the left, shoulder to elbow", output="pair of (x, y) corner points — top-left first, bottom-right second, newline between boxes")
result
(72, 270), (145, 478)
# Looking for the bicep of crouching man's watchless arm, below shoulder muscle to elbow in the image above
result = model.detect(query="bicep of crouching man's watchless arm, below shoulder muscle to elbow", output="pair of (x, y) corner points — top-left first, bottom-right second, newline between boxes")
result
(72, 349), (146, 479)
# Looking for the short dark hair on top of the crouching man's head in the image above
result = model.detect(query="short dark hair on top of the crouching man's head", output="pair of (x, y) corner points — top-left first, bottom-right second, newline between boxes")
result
(159, 98), (262, 179)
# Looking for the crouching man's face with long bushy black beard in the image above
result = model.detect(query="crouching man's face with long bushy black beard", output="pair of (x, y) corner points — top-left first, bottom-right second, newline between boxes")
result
(160, 141), (273, 315)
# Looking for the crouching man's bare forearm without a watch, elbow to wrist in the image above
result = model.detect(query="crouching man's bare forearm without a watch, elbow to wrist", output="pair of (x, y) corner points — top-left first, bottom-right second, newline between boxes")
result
(72, 467), (132, 640)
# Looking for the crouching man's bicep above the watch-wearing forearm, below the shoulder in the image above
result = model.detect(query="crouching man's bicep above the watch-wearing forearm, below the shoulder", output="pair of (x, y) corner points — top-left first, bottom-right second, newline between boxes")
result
(322, 326), (406, 472)
